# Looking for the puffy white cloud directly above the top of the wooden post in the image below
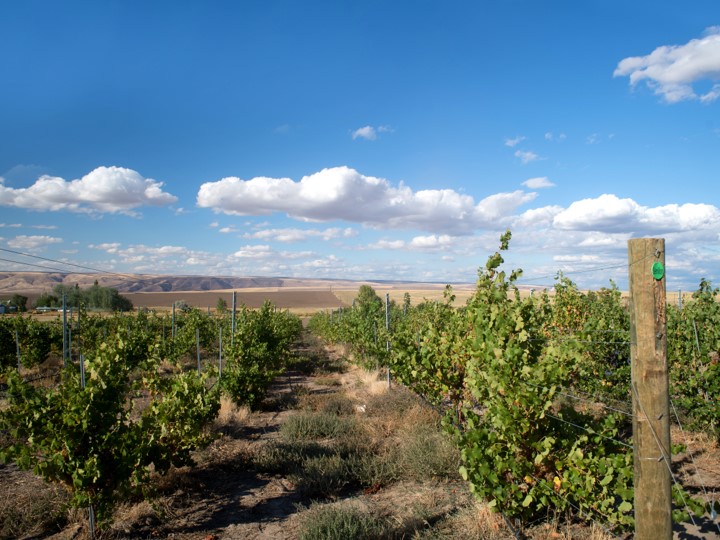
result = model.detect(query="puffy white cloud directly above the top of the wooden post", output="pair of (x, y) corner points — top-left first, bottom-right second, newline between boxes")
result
(553, 194), (720, 234)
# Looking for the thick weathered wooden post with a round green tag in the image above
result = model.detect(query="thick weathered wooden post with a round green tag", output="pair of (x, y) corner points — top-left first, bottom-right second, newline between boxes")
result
(628, 238), (672, 540)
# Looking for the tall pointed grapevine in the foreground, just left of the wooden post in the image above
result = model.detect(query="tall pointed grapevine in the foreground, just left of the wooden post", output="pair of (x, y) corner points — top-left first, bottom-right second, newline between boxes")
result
(451, 234), (633, 525)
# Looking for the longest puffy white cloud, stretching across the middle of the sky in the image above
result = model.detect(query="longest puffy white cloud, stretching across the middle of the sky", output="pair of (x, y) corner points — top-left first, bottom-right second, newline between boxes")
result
(197, 167), (536, 234)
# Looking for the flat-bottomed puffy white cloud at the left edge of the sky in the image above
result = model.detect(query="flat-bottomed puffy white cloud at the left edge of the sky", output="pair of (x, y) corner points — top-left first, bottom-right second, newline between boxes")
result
(0, 167), (177, 215)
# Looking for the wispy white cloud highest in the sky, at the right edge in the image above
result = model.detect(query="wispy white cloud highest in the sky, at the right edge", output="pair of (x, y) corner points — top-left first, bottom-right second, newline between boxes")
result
(613, 26), (720, 103)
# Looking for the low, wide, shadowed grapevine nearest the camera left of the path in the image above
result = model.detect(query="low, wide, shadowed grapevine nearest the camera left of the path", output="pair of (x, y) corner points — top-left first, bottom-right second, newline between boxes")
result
(0, 337), (219, 522)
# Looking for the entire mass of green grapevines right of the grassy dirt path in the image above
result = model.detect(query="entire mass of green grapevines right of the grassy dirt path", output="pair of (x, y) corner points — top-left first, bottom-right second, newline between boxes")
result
(311, 231), (720, 528)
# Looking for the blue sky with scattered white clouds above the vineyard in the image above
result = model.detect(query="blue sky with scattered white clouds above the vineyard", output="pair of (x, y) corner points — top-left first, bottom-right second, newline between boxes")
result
(0, 0), (720, 290)
